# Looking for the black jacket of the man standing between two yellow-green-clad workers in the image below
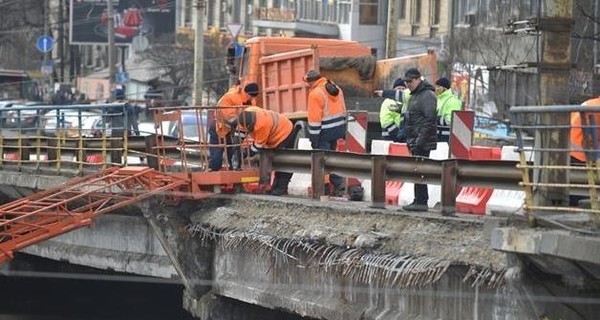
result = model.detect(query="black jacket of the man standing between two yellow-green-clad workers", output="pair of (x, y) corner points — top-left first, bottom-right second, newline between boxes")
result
(406, 81), (437, 150)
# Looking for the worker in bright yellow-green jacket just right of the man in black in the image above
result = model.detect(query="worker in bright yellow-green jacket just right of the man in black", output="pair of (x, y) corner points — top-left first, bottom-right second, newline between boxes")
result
(435, 77), (462, 142)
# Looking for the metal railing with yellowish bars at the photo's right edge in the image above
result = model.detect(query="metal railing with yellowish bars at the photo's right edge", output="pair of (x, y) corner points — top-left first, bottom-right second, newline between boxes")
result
(510, 105), (600, 226)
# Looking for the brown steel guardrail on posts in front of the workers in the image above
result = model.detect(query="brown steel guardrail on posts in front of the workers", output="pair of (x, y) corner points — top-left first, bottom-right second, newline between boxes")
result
(260, 150), (522, 215)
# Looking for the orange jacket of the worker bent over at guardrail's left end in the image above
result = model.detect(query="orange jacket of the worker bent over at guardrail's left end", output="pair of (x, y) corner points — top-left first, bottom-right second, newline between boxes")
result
(238, 107), (294, 152)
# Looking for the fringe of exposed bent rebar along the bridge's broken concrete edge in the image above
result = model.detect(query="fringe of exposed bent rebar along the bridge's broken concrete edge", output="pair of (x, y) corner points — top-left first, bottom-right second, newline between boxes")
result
(188, 224), (506, 289)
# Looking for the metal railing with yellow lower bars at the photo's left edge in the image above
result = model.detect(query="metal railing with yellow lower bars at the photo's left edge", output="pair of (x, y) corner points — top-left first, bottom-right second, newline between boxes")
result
(0, 103), (139, 173)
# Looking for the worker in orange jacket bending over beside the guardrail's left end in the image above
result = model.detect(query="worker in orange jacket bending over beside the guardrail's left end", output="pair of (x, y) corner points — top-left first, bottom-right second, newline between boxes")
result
(237, 107), (294, 196)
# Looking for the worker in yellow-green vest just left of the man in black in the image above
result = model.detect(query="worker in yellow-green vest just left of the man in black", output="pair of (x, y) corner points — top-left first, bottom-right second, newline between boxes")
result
(375, 78), (410, 142)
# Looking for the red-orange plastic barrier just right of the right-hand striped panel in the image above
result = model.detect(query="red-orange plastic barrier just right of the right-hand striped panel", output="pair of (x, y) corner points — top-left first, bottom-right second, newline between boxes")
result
(456, 146), (502, 215)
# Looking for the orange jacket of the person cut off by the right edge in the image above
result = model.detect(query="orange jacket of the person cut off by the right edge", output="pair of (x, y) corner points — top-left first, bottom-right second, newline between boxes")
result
(570, 97), (600, 162)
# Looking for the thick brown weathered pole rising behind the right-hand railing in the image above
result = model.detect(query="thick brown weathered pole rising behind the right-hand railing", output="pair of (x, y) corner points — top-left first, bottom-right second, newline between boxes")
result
(533, 0), (573, 206)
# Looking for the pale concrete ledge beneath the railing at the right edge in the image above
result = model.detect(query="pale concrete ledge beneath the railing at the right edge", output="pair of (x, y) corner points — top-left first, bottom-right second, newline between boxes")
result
(492, 227), (600, 264)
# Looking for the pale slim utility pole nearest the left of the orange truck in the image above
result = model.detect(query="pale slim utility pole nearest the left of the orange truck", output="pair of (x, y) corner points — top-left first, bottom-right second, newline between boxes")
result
(197, 0), (205, 106)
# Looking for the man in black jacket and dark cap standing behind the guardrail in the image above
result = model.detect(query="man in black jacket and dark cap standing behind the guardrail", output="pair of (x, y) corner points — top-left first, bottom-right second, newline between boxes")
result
(402, 68), (437, 211)
